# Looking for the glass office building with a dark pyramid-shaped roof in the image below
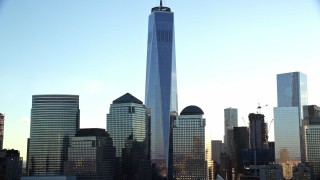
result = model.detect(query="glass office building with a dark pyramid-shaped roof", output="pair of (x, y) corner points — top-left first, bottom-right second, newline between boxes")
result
(107, 93), (151, 180)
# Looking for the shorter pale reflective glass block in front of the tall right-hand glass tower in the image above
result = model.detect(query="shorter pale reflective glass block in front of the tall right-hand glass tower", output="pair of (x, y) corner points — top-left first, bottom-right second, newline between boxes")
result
(274, 107), (301, 178)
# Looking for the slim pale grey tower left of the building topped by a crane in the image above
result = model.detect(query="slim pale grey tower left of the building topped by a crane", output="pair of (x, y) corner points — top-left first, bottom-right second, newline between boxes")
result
(224, 107), (238, 155)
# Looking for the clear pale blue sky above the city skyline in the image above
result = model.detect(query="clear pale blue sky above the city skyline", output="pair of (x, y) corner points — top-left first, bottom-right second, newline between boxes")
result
(0, 0), (320, 159)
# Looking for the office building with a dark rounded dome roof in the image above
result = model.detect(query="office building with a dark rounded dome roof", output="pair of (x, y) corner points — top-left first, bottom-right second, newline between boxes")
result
(173, 106), (207, 180)
